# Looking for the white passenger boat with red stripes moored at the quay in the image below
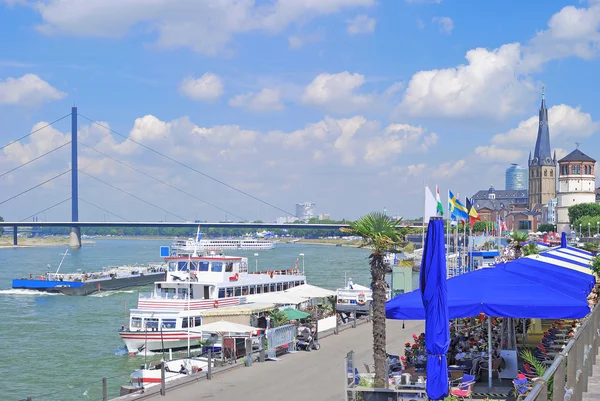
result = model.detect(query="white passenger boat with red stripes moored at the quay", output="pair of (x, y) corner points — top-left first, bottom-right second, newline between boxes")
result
(119, 248), (306, 354)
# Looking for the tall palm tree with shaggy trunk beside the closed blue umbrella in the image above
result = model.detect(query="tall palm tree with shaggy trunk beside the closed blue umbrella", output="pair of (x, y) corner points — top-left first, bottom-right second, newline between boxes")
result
(342, 212), (410, 387)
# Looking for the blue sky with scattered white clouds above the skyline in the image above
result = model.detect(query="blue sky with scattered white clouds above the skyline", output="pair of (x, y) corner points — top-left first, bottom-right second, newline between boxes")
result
(0, 0), (600, 221)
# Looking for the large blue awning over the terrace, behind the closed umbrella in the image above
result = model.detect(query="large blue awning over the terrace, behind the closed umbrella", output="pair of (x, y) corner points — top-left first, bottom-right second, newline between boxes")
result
(386, 244), (595, 320)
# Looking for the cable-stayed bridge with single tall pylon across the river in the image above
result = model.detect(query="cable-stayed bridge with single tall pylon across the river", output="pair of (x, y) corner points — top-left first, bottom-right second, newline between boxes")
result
(0, 107), (347, 248)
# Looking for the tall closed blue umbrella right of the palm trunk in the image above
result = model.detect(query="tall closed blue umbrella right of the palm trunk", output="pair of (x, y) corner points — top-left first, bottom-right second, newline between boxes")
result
(420, 217), (450, 400)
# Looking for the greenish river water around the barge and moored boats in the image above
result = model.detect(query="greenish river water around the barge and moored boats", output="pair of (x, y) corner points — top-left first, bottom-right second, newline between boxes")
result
(0, 239), (380, 401)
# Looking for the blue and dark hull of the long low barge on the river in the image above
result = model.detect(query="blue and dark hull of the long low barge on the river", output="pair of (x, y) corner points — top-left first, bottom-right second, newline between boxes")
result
(12, 272), (165, 295)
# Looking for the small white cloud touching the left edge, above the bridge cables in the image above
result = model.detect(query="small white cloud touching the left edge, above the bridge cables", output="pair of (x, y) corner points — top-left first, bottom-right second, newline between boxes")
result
(0, 74), (67, 106)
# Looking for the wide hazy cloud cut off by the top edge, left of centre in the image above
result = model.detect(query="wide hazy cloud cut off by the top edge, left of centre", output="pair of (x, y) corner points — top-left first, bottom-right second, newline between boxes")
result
(24, 0), (375, 55)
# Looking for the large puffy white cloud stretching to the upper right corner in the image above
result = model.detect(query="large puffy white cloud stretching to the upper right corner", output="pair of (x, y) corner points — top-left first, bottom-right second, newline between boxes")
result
(397, 3), (600, 119)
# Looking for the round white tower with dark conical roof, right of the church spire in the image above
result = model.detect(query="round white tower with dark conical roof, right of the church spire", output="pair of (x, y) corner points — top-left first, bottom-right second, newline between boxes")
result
(556, 149), (596, 232)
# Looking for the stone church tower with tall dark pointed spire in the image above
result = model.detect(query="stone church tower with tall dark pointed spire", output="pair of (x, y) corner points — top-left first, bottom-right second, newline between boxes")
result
(529, 89), (556, 210)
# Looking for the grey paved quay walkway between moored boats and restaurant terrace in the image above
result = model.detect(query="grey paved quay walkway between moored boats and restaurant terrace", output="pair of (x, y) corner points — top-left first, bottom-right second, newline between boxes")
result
(148, 320), (423, 401)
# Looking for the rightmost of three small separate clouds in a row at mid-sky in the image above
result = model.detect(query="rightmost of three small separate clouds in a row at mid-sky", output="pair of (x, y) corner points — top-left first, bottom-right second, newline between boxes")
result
(302, 71), (374, 112)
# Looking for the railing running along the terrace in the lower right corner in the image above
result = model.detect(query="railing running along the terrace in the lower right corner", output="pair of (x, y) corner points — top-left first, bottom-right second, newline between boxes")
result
(525, 304), (600, 401)
